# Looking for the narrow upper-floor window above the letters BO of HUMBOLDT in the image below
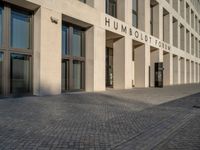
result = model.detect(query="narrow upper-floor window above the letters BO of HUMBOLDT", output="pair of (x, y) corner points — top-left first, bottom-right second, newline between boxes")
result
(132, 0), (138, 27)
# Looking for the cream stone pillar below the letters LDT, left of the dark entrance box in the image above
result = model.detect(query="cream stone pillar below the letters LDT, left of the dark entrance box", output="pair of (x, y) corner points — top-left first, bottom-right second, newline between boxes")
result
(135, 44), (150, 87)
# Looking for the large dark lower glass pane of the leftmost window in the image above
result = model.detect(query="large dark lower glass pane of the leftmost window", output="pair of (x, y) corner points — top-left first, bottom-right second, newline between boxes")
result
(10, 54), (30, 94)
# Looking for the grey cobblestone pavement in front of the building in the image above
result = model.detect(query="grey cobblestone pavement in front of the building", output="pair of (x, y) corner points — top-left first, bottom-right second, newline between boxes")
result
(0, 84), (200, 150)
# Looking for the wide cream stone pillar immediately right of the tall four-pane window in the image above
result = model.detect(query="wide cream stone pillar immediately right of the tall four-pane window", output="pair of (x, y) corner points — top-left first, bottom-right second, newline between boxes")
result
(85, 26), (106, 91)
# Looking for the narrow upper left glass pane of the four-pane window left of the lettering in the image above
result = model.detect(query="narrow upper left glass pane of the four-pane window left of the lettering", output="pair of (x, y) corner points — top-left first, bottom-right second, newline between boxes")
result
(62, 25), (69, 55)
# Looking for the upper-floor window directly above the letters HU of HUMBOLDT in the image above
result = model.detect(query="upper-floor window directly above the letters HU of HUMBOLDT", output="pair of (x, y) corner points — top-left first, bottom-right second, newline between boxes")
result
(106, 0), (117, 18)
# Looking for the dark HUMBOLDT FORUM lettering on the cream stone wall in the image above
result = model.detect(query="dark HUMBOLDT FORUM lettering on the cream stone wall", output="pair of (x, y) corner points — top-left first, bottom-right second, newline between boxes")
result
(105, 17), (171, 50)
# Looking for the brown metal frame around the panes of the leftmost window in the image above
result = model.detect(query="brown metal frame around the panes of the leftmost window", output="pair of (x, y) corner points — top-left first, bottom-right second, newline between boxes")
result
(0, 2), (34, 96)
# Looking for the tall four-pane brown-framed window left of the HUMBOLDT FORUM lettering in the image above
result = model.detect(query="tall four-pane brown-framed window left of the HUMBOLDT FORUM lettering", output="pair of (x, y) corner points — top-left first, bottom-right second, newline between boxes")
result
(62, 23), (85, 91)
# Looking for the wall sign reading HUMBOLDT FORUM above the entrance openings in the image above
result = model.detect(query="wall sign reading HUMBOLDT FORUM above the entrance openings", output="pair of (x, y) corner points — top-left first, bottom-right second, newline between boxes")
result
(104, 15), (171, 51)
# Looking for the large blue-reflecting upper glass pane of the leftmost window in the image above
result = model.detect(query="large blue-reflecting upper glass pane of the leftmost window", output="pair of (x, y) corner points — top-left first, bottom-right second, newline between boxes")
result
(11, 10), (30, 49)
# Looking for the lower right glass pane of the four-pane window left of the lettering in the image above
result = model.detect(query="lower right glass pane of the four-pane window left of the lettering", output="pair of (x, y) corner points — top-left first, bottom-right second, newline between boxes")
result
(73, 61), (83, 90)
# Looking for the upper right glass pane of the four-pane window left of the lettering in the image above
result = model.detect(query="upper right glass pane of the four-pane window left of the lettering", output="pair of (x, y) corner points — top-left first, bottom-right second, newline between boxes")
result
(72, 28), (82, 56)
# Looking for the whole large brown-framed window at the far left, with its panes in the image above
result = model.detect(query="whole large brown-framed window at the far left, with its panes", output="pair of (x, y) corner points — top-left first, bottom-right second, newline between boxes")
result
(0, 2), (33, 96)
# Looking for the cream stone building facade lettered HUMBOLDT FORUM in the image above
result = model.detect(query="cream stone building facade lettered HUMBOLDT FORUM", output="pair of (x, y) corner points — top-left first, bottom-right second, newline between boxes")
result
(0, 0), (200, 96)
